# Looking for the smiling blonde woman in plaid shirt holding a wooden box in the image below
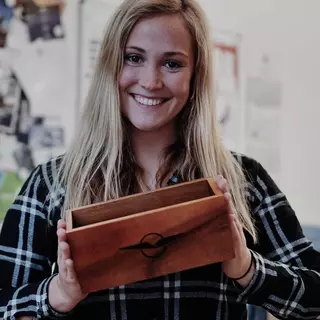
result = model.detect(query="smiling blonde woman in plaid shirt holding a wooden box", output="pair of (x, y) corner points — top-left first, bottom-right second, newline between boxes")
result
(0, 0), (320, 320)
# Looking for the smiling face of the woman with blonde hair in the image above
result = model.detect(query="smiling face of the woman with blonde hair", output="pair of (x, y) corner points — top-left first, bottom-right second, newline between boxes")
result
(120, 14), (194, 131)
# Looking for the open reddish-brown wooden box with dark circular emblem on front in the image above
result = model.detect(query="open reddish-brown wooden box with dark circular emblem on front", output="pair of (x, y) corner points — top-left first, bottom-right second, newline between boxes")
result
(67, 179), (234, 292)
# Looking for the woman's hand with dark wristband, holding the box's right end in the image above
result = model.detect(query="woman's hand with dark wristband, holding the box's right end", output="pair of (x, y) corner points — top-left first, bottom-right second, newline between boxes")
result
(215, 175), (255, 286)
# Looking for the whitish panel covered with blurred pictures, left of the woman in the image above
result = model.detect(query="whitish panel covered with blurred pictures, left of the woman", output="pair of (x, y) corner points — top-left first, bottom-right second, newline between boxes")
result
(0, 0), (74, 220)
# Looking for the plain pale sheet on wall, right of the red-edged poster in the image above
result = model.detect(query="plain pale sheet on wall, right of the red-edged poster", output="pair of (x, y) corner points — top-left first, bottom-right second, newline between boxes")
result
(246, 77), (282, 183)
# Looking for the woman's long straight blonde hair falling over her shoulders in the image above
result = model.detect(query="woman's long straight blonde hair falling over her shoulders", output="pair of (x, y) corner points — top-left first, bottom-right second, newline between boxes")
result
(55, 0), (256, 240)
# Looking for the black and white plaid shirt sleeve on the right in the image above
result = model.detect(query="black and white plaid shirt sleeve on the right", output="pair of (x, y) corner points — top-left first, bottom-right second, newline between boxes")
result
(238, 164), (320, 319)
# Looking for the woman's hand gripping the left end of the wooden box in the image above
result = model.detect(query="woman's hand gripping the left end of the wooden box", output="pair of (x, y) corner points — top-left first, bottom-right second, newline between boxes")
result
(49, 220), (86, 313)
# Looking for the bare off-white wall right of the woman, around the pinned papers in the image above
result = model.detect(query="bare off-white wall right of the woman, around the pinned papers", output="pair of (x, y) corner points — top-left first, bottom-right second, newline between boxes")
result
(199, 0), (320, 225)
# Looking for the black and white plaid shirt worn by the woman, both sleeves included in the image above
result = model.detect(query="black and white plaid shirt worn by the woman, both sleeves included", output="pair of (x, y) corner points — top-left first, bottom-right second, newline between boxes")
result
(0, 155), (320, 320)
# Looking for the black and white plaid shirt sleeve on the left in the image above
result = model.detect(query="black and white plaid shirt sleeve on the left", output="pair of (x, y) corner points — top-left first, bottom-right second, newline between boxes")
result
(0, 165), (63, 320)
